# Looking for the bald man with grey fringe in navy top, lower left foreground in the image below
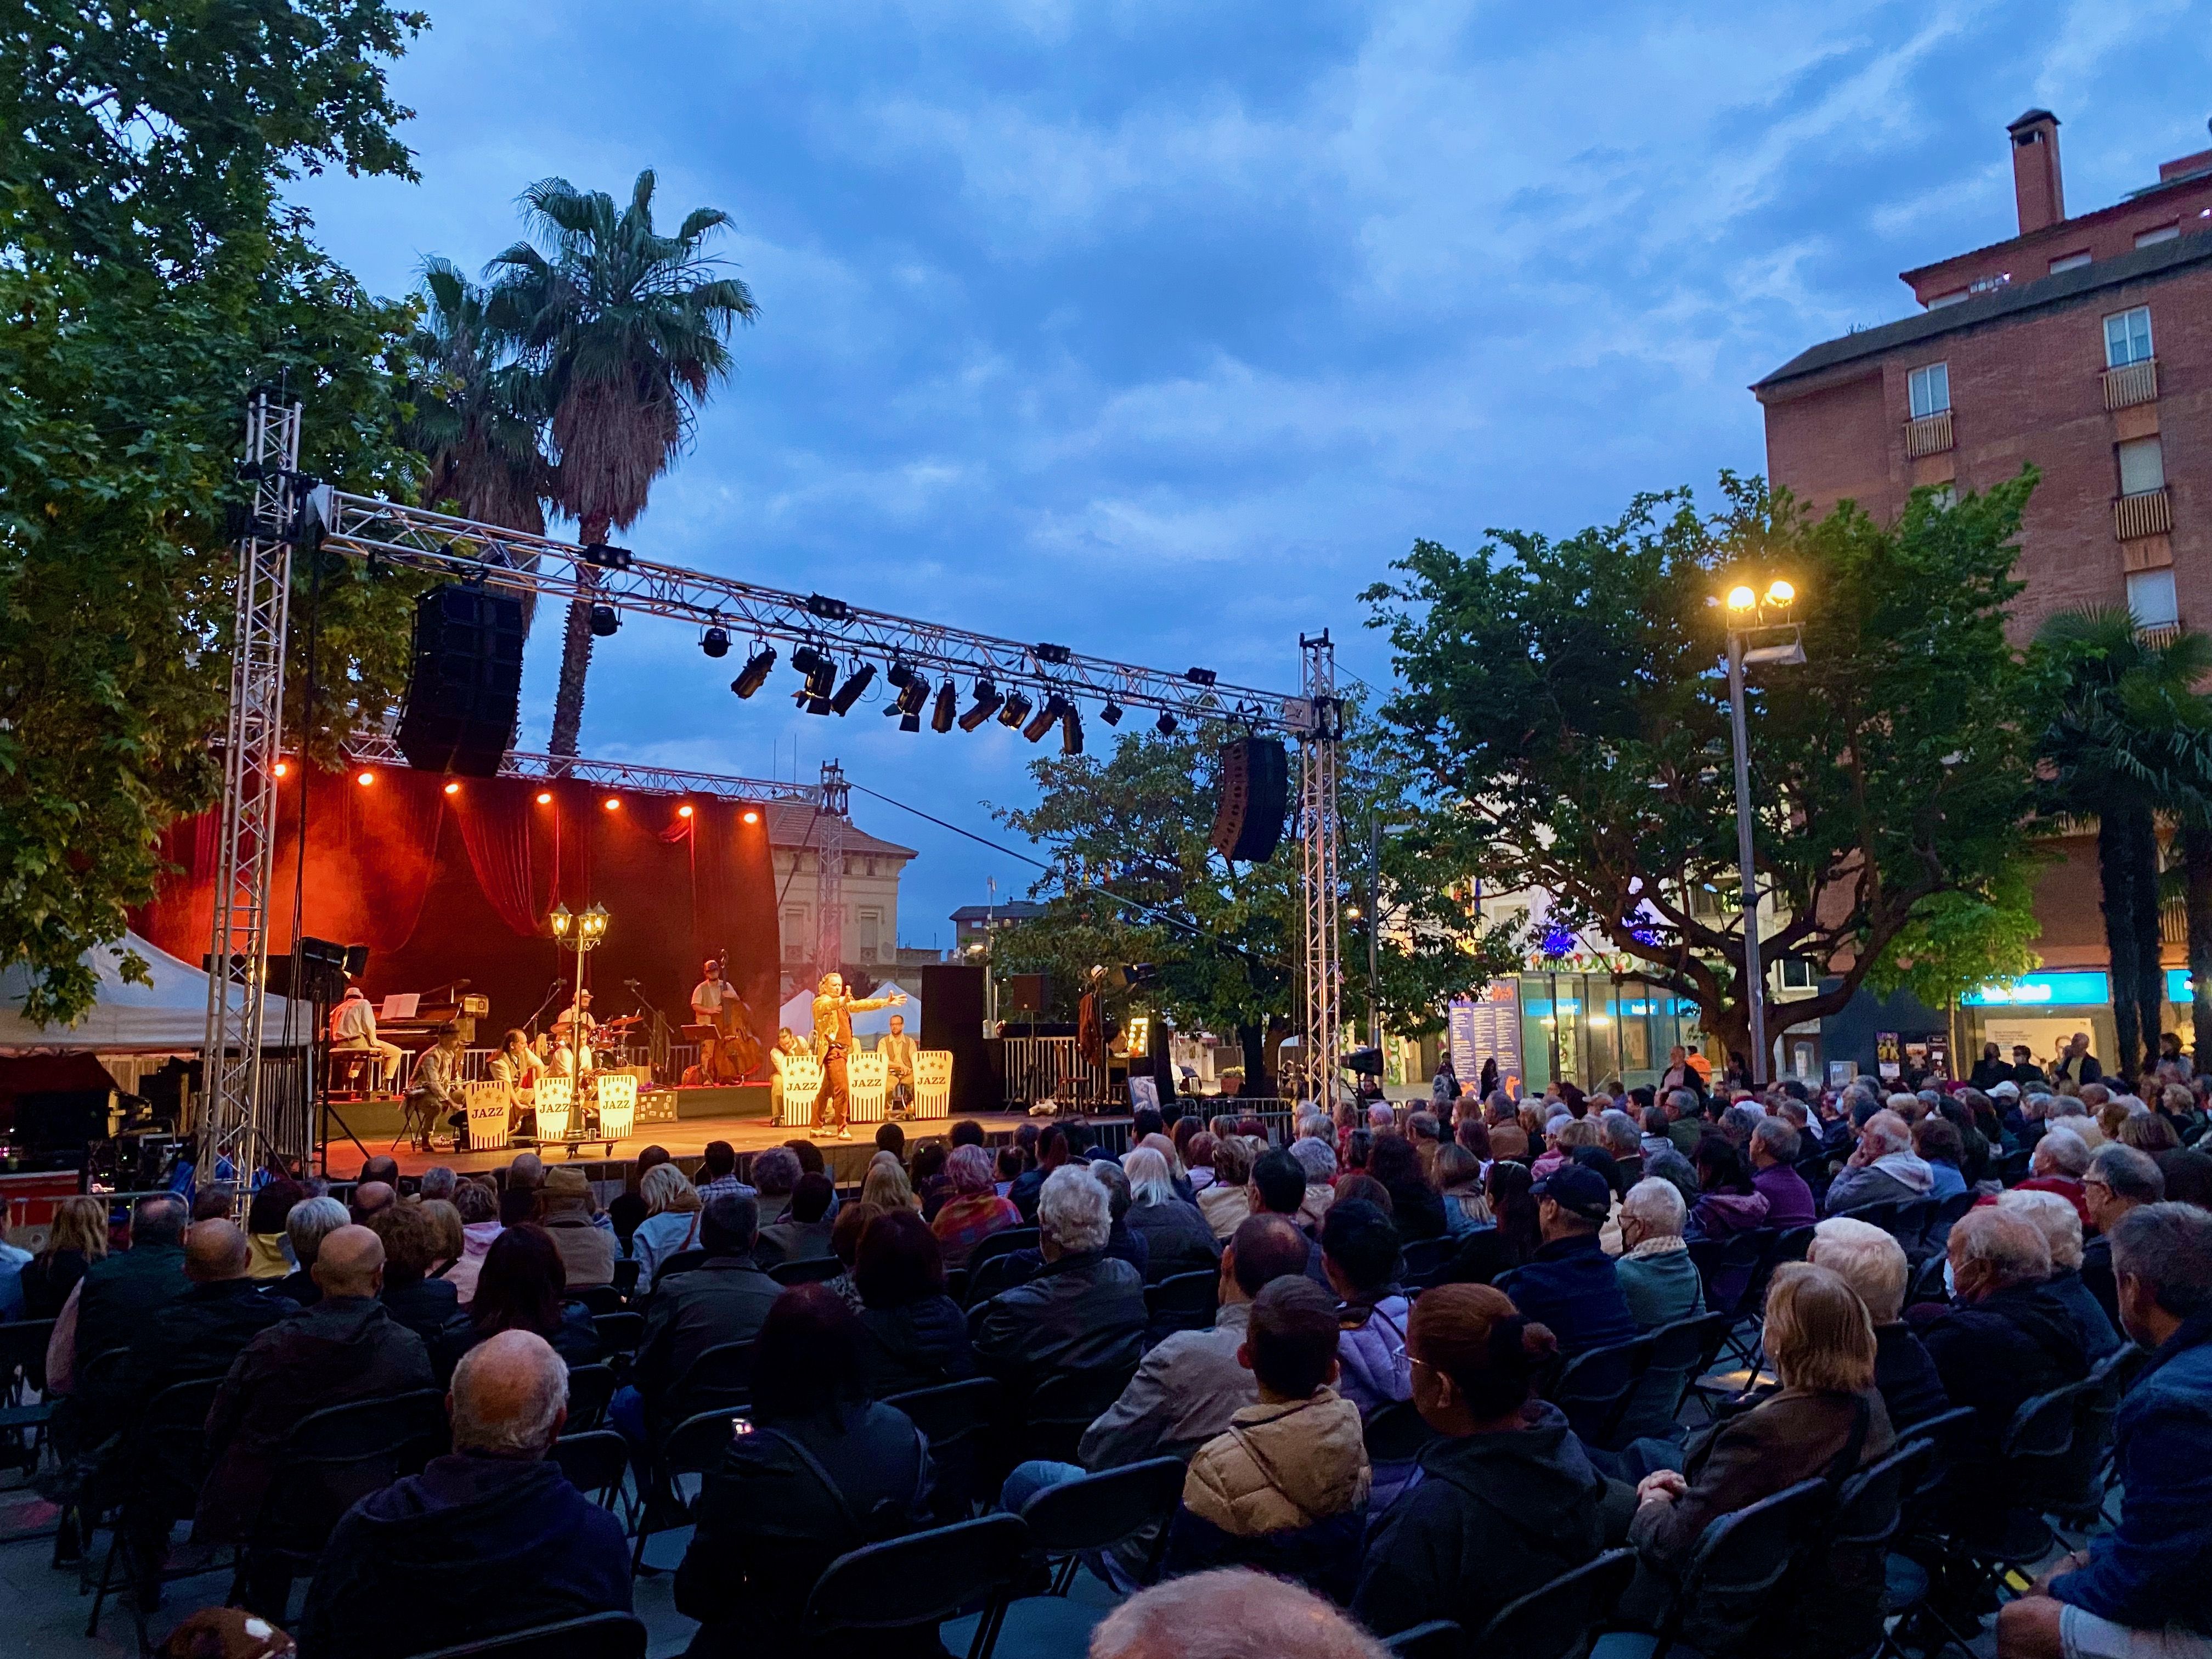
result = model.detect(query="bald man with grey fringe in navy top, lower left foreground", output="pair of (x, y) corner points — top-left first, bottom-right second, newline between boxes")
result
(298, 1331), (630, 1659)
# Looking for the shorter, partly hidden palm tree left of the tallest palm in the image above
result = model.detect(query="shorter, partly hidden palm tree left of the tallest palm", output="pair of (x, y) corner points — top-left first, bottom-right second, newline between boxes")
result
(407, 255), (553, 628)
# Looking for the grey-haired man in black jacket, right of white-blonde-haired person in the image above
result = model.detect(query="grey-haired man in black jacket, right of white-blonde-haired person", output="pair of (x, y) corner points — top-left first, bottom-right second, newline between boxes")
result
(1907, 1205), (2088, 1522)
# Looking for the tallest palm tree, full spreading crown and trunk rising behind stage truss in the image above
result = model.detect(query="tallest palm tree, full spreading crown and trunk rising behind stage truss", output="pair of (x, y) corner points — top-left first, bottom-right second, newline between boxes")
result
(487, 168), (757, 754)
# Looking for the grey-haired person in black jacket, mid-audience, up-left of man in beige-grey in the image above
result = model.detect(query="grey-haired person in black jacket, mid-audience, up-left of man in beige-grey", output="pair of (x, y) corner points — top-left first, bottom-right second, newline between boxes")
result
(975, 1164), (1146, 1391)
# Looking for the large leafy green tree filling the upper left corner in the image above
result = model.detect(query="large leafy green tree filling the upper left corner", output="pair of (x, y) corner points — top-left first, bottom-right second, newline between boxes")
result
(0, 0), (420, 1022)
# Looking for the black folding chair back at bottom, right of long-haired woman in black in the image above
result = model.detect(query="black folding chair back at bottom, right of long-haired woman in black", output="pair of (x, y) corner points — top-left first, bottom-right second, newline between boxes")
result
(805, 1515), (1029, 1659)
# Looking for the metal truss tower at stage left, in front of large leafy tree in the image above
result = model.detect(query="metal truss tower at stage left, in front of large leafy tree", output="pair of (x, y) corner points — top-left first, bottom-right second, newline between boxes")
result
(197, 392), (301, 1205)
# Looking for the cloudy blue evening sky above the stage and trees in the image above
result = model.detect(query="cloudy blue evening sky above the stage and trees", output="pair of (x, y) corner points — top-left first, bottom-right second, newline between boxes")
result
(298, 0), (2212, 945)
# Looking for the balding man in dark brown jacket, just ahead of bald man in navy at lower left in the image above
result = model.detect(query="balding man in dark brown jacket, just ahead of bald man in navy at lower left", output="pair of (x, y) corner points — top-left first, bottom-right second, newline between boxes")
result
(193, 1226), (433, 1617)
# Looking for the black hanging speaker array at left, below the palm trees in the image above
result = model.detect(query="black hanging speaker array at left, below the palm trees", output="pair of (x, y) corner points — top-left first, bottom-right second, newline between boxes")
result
(396, 582), (524, 778)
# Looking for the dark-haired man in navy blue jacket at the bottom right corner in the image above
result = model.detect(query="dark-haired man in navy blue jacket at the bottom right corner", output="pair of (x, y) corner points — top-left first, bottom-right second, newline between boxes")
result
(1997, 1203), (2212, 1659)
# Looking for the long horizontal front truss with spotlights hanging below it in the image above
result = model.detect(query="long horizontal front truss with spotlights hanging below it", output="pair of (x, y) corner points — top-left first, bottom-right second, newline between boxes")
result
(309, 487), (1305, 732)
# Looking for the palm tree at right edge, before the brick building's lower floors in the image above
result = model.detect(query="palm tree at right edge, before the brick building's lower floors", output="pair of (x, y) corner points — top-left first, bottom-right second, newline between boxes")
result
(2035, 606), (2212, 1077)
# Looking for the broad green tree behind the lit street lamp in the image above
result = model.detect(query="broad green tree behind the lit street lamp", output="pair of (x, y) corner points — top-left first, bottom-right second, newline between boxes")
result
(1365, 471), (2035, 1070)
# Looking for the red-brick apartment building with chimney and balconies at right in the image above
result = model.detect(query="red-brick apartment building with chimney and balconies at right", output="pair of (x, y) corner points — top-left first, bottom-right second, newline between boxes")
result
(1752, 109), (2212, 1079)
